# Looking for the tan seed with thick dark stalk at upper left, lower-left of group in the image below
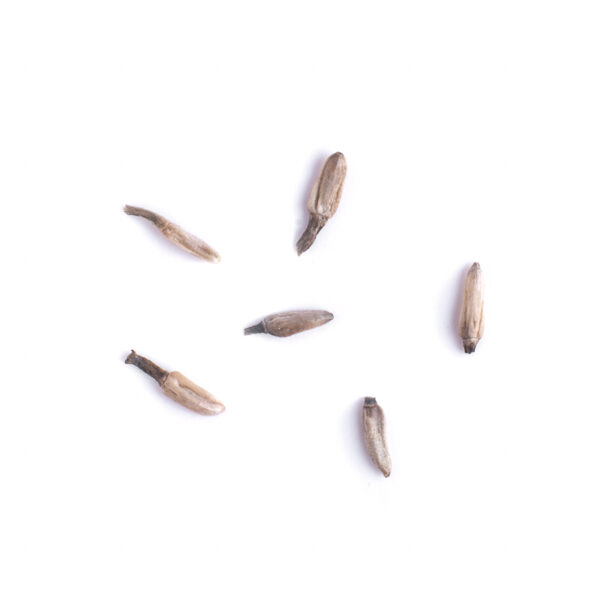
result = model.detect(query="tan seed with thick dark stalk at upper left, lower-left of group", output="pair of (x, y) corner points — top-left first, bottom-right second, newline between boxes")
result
(125, 350), (225, 415)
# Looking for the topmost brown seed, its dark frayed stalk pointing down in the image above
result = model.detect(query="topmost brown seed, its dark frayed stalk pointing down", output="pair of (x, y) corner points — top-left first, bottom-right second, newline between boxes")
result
(296, 152), (346, 255)
